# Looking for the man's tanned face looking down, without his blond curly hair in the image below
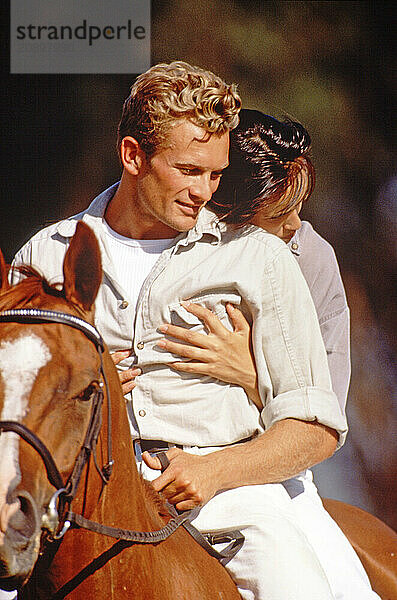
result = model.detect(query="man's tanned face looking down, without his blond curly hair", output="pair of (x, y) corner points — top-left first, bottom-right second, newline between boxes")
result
(134, 119), (229, 239)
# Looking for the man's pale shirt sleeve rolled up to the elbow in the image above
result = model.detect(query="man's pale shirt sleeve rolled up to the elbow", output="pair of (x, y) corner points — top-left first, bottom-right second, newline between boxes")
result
(252, 247), (347, 446)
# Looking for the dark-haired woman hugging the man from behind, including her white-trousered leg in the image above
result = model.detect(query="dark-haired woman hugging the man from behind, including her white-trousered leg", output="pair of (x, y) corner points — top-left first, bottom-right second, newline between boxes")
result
(154, 110), (377, 600)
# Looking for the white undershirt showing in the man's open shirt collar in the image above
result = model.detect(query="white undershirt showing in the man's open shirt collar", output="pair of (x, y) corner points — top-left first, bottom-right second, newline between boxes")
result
(103, 219), (174, 308)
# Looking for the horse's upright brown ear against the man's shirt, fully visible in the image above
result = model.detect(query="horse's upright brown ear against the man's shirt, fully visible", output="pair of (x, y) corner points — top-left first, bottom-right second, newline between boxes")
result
(63, 221), (102, 310)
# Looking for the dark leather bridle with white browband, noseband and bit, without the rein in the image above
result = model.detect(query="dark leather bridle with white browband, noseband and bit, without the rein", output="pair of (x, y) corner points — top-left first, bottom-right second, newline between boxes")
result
(0, 308), (113, 539)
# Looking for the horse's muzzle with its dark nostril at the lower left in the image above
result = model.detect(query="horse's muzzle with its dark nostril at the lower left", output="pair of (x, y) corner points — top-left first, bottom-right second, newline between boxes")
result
(0, 491), (41, 590)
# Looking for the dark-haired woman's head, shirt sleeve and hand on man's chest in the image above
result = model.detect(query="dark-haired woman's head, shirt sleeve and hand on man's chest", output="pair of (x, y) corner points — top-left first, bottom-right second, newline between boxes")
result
(159, 110), (350, 412)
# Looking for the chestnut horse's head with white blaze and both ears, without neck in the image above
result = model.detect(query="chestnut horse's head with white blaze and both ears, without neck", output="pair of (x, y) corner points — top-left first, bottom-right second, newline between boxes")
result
(0, 222), (102, 589)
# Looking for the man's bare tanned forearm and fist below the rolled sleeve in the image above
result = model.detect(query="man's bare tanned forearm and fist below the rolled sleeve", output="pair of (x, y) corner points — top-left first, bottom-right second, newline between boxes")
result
(143, 419), (338, 510)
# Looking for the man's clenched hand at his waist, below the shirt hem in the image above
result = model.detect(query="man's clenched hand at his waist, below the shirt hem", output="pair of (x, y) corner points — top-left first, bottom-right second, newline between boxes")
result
(142, 448), (218, 510)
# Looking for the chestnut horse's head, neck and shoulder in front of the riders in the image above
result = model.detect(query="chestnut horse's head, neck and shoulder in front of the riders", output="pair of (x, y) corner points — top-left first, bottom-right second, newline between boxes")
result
(0, 222), (240, 600)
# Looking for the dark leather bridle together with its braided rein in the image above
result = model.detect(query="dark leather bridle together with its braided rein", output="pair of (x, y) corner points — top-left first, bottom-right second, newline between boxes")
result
(0, 308), (244, 562)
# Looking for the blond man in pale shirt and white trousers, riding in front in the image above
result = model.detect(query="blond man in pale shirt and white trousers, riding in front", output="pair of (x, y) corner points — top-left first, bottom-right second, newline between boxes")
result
(16, 63), (347, 600)
